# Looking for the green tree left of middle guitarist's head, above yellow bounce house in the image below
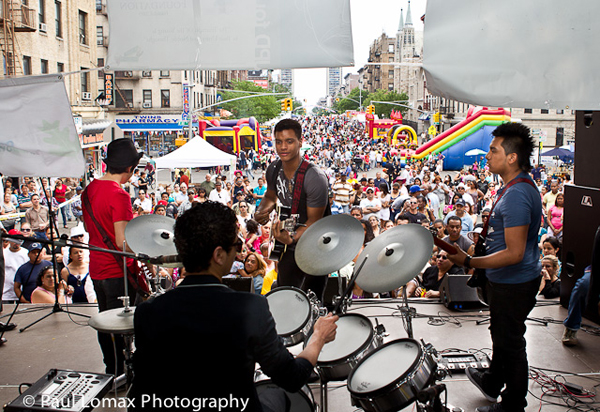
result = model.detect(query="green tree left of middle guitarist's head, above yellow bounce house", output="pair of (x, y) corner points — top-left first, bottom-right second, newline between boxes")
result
(219, 82), (285, 123)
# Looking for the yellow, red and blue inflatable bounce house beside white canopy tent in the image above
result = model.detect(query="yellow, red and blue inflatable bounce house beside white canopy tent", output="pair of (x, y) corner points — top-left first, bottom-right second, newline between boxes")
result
(198, 117), (261, 154)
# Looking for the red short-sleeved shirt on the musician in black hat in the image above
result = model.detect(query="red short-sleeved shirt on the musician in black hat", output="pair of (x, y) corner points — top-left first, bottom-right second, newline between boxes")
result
(83, 179), (135, 280)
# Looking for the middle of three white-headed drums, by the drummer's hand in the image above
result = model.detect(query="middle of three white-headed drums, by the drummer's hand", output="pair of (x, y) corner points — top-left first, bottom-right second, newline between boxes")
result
(305, 313), (382, 381)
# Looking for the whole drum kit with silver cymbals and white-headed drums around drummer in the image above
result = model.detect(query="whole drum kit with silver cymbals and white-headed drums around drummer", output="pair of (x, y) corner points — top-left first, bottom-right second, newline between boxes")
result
(89, 214), (449, 412)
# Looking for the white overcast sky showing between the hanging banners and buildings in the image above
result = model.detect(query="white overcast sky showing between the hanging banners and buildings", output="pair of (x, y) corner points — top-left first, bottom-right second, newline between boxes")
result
(294, 0), (427, 106)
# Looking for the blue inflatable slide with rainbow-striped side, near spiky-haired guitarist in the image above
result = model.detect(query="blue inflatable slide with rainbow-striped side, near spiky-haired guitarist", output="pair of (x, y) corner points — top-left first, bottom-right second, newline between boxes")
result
(411, 107), (511, 170)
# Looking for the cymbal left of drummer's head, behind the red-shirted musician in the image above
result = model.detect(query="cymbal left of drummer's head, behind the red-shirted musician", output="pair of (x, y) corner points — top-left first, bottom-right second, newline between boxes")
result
(124, 215), (177, 256)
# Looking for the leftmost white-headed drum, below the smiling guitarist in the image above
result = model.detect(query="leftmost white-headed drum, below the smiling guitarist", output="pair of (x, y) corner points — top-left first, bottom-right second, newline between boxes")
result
(265, 287), (319, 346)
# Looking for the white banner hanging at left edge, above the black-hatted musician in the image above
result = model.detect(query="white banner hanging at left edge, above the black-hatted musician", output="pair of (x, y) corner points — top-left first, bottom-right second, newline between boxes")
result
(0, 75), (85, 177)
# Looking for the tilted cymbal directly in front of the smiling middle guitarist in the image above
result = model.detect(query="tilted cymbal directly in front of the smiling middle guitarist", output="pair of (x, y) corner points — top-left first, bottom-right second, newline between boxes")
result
(296, 214), (365, 276)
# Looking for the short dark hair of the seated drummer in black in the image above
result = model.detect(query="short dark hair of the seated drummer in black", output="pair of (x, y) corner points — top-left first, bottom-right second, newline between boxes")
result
(175, 201), (238, 273)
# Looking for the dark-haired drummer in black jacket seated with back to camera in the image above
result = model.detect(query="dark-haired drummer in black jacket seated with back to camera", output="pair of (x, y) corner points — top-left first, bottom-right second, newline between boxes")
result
(131, 201), (338, 411)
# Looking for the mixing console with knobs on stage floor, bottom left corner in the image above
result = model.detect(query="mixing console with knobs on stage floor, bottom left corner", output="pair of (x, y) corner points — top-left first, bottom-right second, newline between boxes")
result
(4, 369), (113, 412)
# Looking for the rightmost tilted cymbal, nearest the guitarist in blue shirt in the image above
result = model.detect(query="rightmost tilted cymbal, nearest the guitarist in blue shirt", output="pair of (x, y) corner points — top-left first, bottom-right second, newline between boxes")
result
(356, 224), (433, 293)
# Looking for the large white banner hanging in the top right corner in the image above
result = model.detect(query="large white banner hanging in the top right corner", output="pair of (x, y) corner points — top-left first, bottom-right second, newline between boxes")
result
(423, 0), (600, 110)
